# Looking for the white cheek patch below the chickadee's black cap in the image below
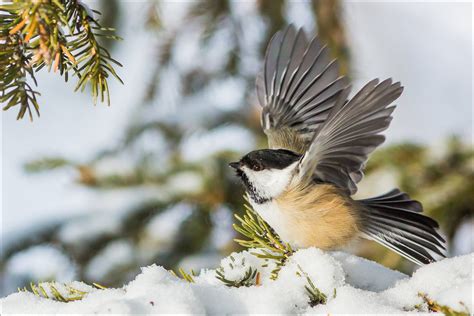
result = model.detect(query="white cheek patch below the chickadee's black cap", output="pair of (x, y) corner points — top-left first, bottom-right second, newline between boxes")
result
(242, 162), (297, 198)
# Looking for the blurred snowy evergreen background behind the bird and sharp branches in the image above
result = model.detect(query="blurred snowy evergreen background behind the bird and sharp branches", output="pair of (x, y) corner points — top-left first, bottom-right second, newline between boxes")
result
(0, 0), (474, 296)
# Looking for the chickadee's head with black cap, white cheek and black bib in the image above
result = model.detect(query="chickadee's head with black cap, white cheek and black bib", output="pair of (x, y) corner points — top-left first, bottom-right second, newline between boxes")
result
(229, 149), (301, 204)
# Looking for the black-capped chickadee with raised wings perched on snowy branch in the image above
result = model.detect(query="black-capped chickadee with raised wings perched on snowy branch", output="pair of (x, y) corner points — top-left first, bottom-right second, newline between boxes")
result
(229, 25), (446, 265)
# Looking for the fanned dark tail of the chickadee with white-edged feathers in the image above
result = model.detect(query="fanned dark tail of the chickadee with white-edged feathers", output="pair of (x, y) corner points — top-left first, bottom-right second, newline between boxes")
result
(359, 189), (446, 265)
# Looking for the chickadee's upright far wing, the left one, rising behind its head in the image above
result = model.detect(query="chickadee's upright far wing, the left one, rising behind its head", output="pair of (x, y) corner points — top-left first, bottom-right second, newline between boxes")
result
(257, 25), (348, 153)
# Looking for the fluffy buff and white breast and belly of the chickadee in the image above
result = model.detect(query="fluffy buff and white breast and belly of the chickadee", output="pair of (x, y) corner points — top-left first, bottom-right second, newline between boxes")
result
(248, 185), (359, 249)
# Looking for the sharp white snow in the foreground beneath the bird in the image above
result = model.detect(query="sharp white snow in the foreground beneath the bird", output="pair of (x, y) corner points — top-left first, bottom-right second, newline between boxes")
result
(0, 248), (473, 315)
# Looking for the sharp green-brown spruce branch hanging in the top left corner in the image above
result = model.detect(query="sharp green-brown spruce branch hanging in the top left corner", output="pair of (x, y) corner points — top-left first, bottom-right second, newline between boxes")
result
(0, 0), (123, 119)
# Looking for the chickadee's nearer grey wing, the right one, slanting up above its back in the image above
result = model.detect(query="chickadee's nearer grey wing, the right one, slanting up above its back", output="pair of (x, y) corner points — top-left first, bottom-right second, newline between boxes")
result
(299, 79), (403, 194)
